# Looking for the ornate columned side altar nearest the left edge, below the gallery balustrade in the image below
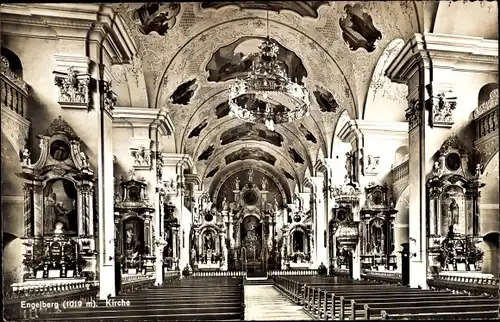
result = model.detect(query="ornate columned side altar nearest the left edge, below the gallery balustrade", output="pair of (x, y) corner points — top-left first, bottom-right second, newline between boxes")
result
(17, 117), (97, 281)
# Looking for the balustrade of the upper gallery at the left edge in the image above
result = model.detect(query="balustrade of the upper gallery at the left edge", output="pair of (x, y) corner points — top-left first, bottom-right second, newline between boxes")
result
(0, 56), (29, 118)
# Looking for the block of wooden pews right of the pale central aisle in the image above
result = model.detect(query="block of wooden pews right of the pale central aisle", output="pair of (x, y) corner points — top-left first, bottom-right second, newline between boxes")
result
(273, 276), (498, 320)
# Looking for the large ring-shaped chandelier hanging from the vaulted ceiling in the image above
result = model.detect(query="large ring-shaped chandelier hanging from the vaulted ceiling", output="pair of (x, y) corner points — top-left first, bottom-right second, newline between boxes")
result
(229, 3), (310, 131)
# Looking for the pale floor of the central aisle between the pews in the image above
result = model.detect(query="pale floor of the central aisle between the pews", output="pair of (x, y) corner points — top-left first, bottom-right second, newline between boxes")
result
(245, 285), (311, 321)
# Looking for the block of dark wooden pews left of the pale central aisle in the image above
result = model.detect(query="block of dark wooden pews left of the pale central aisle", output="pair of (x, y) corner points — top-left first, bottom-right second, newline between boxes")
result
(34, 277), (245, 322)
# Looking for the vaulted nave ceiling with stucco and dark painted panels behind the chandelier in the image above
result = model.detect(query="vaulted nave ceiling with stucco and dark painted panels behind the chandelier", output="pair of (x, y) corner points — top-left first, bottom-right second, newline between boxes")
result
(114, 1), (419, 191)
